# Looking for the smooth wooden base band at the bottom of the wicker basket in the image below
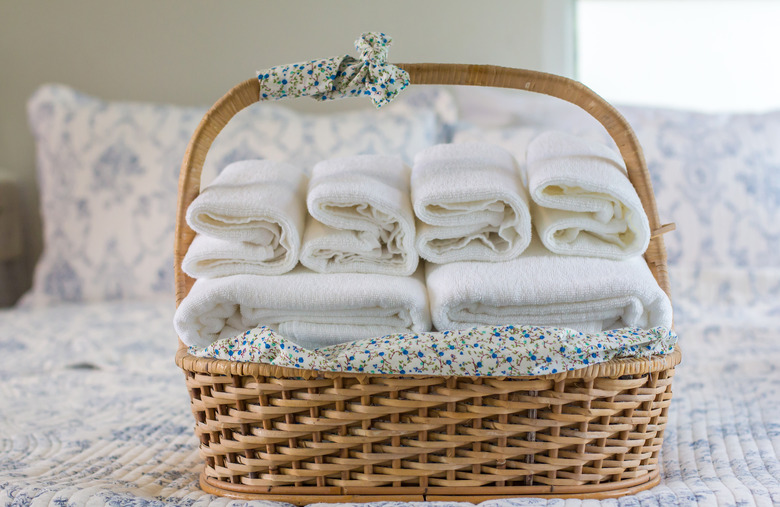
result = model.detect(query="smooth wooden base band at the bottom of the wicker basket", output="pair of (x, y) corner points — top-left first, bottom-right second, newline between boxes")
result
(200, 470), (661, 505)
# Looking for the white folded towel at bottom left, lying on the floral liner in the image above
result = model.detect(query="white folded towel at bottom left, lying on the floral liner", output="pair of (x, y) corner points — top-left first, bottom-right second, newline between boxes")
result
(174, 266), (431, 348)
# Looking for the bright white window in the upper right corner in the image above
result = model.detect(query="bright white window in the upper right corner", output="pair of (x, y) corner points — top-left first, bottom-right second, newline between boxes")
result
(576, 0), (780, 111)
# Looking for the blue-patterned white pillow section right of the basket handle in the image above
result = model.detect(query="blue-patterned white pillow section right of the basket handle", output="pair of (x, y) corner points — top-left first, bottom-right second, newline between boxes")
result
(620, 107), (780, 268)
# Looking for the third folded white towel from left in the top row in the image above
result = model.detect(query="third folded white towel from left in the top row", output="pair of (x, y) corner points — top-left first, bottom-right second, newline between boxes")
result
(412, 143), (531, 264)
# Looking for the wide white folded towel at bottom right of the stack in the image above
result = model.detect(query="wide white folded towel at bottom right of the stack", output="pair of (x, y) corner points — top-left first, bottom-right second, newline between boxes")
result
(426, 240), (672, 332)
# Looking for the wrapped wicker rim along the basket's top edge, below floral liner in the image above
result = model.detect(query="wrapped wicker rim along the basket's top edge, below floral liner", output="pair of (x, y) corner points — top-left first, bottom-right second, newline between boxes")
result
(176, 341), (682, 384)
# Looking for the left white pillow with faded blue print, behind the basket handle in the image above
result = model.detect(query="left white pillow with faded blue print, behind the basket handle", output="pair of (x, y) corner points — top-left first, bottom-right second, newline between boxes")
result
(22, 85), (455, 306)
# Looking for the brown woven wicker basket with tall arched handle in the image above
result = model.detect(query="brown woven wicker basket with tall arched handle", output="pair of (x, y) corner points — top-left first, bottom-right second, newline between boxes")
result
(175, 64), (680, 505)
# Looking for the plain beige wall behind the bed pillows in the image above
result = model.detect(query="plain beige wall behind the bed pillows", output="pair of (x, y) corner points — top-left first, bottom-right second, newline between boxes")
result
(0, 0), (573, 294)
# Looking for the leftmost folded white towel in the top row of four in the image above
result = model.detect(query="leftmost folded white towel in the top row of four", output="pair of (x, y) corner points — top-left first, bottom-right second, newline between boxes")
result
(185, 160), (307, 276)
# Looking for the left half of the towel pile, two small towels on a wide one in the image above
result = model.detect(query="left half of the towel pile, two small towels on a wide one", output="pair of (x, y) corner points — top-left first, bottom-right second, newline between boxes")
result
(174, 159), (431, 348)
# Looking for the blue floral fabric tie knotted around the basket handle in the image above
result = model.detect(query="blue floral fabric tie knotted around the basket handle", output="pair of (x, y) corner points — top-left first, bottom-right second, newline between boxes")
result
(257, 32), (409, 107)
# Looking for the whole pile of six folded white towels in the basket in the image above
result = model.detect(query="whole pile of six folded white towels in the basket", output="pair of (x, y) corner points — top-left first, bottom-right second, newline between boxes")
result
(174, 132), (672, 354)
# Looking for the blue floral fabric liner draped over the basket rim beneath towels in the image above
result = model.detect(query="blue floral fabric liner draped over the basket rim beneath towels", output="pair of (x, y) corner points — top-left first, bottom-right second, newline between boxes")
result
(190, 326), (677, 376)
